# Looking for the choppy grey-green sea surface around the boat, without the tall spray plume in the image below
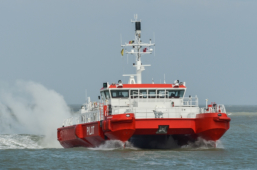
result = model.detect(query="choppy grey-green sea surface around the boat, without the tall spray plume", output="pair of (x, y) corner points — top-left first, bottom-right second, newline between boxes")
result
(0, 106), (257, 169)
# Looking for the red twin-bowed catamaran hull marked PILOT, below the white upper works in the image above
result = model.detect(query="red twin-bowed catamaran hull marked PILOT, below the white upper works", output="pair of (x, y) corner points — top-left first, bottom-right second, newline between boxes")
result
(57, 113), (230, 149)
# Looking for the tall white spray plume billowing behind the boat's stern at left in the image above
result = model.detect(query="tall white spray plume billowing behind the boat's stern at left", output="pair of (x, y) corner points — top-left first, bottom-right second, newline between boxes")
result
(0, 81), (71, 147)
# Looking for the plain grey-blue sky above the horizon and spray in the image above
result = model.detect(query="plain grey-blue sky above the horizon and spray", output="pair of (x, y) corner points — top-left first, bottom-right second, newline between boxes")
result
(0, 0), (257, 105)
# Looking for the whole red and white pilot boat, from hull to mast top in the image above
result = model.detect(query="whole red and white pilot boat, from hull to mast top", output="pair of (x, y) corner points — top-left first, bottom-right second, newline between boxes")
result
(57, 15), (230, 149)
